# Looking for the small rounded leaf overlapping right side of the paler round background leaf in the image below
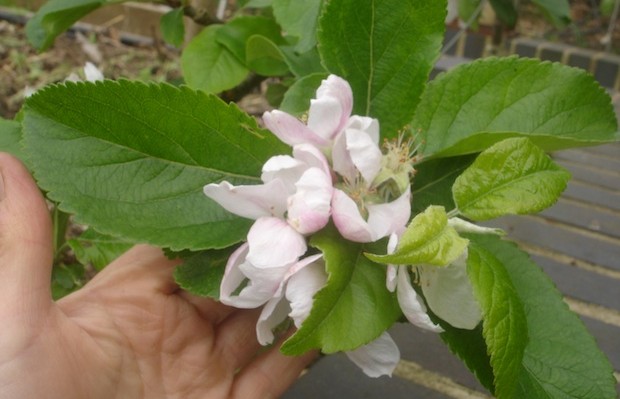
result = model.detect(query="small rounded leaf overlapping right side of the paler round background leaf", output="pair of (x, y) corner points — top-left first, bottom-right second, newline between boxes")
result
(245, 35), (289, 76)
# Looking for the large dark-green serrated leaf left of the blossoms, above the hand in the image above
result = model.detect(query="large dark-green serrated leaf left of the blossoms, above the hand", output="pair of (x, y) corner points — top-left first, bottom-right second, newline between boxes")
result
(24, 81), (290, 250)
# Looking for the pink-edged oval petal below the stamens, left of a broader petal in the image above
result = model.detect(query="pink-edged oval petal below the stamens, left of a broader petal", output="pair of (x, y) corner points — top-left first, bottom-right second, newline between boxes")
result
(332, 189), (375, 242)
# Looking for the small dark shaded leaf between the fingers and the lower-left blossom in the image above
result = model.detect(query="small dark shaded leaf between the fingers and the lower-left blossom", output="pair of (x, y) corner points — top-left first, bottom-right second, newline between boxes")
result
(174, 247), (235, 299)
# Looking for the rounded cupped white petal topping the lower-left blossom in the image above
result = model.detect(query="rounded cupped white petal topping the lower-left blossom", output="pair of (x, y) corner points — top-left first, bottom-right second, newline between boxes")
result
(247, 217), (308, 269)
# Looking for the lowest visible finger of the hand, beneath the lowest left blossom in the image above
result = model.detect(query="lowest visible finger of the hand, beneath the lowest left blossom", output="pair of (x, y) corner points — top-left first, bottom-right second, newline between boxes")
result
(231, 338), (318, 398)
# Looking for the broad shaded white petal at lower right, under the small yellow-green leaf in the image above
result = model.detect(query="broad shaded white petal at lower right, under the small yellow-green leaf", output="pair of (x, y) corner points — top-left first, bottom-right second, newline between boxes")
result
(418, 254), (482, 330)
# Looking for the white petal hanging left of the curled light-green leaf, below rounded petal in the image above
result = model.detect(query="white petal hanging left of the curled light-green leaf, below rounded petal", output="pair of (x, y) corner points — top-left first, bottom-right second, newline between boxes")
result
(286, 255), (327, 328)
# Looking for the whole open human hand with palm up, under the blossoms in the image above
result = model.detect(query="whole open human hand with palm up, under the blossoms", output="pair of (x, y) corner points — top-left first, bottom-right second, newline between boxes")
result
(0, 154), (316, 399)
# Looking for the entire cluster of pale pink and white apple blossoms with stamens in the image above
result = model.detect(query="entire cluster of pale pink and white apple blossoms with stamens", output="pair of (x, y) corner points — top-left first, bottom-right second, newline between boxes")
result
(204, 75), (480, 377)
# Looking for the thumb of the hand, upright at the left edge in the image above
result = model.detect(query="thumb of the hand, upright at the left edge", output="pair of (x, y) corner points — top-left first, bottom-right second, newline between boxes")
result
(0, 153), (53, 312)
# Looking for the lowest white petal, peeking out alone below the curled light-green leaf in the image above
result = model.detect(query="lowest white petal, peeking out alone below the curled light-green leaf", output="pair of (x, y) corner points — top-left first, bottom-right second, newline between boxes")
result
(345, 332), (400, 378)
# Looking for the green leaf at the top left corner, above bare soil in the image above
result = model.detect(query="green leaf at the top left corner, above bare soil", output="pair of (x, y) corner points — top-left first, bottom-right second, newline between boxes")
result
(26, 0), (110, 51)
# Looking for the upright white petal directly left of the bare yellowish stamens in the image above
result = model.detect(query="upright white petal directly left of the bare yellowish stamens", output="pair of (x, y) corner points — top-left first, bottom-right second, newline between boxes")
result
(345, 129), (383, 185)
